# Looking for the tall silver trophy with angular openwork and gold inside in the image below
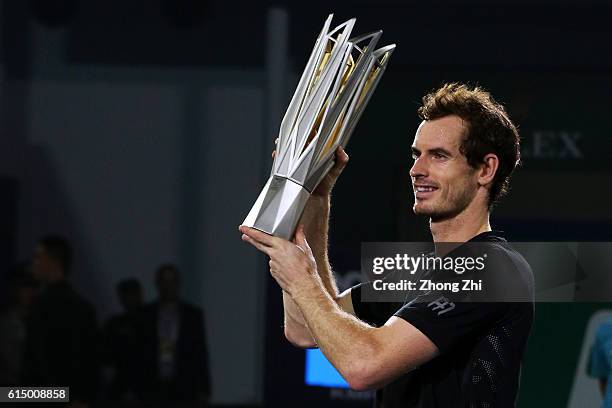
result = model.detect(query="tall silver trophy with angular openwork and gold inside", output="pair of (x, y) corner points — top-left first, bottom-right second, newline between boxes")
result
(242, 14), (395, 239)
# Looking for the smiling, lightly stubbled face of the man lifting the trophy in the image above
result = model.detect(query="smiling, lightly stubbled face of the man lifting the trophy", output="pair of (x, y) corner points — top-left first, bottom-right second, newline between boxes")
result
(410, 115), (478, 221)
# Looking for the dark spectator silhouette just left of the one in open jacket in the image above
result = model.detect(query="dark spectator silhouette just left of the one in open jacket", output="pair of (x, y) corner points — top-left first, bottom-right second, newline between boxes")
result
(104, 279), (143, 406)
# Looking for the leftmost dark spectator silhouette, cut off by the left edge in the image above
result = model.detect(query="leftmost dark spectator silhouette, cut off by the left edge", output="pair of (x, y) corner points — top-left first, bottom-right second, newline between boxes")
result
(0, 262), (36, 386)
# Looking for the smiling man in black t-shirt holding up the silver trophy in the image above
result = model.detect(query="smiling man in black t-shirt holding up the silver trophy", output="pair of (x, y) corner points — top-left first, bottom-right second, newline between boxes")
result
(240, 84), (533, 408)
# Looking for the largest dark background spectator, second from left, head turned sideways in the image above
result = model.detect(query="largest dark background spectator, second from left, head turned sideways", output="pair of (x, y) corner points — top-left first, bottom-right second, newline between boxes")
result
(22, 235), (98, 406)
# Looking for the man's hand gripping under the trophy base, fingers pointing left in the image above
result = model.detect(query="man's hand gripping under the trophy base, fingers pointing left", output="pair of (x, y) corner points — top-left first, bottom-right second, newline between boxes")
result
(239, 225), (322, 295)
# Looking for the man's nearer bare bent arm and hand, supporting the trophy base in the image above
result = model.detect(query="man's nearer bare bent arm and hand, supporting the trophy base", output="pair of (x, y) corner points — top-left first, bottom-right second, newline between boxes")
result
(240, 227), (438, 390)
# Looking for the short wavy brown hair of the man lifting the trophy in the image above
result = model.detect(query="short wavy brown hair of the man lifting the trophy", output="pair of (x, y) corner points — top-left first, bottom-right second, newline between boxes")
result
(417, 83), (521, 208)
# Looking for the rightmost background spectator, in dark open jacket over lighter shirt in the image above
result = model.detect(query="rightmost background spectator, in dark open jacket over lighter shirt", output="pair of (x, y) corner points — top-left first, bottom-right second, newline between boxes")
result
(143, 264), (210, 406)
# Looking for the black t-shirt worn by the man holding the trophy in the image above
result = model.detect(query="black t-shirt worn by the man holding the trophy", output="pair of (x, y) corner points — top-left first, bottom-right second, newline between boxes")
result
(351, 232), (534, 408)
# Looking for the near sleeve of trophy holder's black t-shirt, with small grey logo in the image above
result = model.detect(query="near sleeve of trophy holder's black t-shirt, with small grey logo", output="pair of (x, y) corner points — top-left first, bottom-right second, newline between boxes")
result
(395, 294), (510, 354)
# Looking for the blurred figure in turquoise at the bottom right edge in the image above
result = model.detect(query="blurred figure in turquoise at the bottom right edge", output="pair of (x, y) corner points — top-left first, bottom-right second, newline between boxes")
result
(588, 321), (612, 408)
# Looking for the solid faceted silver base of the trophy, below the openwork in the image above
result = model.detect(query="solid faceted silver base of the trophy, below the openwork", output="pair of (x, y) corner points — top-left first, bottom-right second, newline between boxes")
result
(242, 175), (310, 239)
